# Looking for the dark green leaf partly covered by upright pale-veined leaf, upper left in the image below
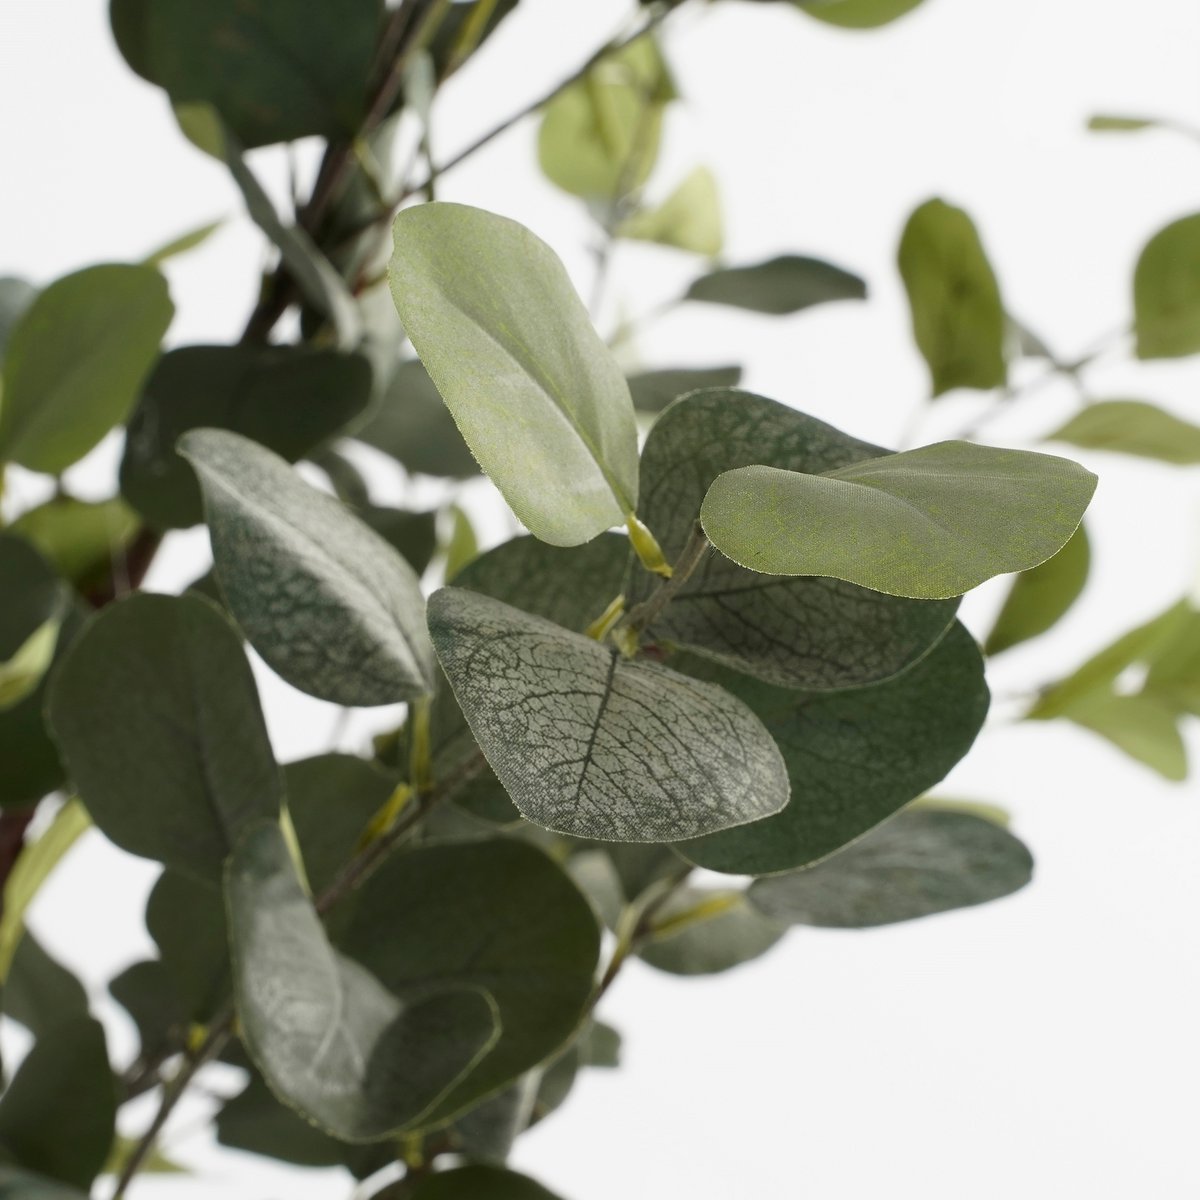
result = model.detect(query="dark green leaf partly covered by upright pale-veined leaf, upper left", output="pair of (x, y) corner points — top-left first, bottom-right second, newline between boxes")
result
(121, 346), (371, 529)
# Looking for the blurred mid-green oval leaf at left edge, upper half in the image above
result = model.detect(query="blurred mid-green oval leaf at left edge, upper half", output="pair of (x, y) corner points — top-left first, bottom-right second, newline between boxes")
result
(0, 265), (174, 474)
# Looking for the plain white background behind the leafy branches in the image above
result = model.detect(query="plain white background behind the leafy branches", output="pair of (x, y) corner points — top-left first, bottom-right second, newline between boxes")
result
(0, 0), (1200, 1200)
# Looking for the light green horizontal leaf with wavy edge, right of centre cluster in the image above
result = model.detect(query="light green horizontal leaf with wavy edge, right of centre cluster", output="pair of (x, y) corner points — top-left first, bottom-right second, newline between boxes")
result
(701, 442), (1096, 600)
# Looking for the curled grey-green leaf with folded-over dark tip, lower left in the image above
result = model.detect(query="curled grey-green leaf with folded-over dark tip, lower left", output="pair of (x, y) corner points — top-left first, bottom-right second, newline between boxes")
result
(226, 823), (500, 1142)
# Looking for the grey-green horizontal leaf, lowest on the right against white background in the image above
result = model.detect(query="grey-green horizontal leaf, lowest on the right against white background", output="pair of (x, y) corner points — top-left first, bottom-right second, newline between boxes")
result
(749, 809), (1033, 929)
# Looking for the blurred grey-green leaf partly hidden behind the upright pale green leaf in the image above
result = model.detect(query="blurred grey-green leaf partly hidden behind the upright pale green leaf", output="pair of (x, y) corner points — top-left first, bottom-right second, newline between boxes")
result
(354, 359), (479, 479)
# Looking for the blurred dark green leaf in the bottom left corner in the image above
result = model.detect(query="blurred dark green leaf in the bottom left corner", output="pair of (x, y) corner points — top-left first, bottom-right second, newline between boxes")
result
(0, 1016), (116, 1194)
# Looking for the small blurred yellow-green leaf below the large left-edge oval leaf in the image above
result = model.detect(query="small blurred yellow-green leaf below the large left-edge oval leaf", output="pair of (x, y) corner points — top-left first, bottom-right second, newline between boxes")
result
(12, 496), (139, 592)
